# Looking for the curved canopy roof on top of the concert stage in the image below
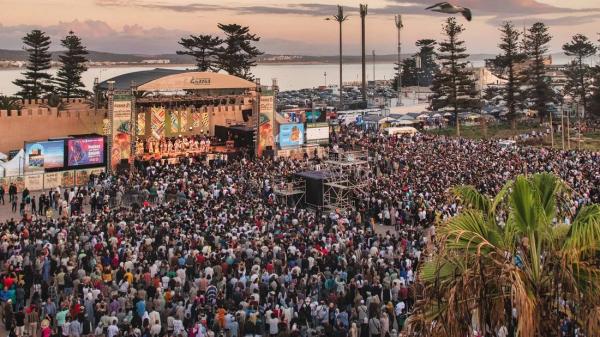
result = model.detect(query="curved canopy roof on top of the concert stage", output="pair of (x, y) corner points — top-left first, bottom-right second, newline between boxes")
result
(99, 68), (256, 91)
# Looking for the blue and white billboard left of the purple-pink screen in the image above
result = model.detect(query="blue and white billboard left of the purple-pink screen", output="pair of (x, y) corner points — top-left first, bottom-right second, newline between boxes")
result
(24, 140), (65, 172)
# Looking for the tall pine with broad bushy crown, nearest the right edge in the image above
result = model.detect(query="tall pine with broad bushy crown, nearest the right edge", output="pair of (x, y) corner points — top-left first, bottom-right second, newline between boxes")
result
(563, 34), (597, 115)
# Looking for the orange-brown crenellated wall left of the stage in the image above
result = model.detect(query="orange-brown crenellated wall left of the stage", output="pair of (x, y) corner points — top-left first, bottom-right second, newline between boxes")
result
(0, 99), (106, 153)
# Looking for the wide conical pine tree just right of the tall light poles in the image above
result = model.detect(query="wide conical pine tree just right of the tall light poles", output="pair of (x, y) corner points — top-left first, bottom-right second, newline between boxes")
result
(430, 17), (479, 137)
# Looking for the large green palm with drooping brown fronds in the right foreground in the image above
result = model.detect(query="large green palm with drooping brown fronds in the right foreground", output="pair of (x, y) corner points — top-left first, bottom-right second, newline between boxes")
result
(408, 173), (600, 337)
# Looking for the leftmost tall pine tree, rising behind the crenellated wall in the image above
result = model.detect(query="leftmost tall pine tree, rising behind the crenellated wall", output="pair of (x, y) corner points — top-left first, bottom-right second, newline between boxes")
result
(13, 29), (52, 100)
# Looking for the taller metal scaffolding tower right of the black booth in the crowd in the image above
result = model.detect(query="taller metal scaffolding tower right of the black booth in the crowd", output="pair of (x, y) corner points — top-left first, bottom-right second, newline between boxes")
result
(323, 151), (369, 211)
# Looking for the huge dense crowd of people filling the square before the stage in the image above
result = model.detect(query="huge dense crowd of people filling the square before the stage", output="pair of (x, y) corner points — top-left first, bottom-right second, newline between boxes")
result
(0, 128), (600, 337)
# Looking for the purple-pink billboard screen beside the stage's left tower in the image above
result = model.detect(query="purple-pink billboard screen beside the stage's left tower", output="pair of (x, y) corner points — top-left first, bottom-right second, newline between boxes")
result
(67, 137), (104, 167)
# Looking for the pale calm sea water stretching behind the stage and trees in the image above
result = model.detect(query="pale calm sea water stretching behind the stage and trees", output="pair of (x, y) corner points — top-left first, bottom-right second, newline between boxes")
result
(0, 63), (404, 95)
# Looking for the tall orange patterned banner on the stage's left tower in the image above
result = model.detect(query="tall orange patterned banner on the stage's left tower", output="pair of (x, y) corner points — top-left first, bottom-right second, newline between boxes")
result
(110, 95), (132, 170)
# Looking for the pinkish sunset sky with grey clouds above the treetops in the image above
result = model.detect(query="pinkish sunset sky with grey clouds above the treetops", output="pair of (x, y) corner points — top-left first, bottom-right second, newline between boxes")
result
(0, 0), (600, 55)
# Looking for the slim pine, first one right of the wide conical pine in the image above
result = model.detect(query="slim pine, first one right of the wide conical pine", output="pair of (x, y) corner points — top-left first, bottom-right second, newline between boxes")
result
(492, 22), (527, 129)
